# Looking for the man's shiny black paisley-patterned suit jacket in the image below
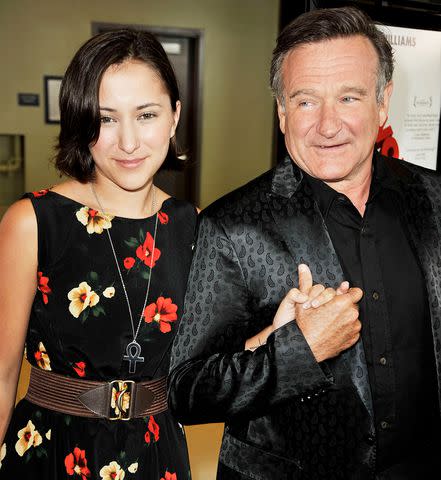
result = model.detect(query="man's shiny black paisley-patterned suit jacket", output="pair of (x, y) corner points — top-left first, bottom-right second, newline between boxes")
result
(169, 157), (441, 480)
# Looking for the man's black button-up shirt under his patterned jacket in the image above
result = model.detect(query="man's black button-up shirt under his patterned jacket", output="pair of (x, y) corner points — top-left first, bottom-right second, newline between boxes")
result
(305, 160), (441, 478)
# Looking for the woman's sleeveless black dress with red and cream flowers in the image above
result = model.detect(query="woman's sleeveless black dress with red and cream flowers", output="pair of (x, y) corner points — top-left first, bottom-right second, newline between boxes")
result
(0, 190), (197, 480)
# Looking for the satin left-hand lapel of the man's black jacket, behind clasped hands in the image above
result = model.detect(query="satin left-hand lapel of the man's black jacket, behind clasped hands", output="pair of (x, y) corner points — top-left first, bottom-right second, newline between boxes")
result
(268, 157), (373, 416)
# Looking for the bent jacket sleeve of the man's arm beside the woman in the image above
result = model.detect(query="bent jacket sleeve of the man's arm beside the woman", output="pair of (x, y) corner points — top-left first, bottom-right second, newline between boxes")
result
(168, 214), (332, 424)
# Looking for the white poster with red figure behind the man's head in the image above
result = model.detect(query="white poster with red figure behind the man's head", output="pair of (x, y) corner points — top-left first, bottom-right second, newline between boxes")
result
(377, 25), (441, 170)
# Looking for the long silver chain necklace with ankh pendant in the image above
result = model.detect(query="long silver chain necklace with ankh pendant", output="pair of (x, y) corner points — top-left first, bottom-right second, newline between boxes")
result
(90, 183), (158, 373)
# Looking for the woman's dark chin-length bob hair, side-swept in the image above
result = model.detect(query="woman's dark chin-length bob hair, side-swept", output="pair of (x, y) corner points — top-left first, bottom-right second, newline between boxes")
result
(55, 29), (183, 183)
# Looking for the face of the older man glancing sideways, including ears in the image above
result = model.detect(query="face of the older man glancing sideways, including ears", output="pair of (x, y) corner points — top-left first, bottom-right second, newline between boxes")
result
(278, 36), (392, 189)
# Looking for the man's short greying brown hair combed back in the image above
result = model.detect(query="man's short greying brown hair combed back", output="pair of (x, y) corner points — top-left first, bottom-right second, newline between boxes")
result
(270, 7), (394, 105)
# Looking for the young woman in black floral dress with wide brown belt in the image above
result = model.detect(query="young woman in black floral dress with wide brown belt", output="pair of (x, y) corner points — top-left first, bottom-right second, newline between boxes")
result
(0, 30), (197, 480)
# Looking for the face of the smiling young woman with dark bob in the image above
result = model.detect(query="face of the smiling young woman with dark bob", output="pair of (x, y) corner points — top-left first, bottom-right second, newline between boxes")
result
(90, 60), (180, 191)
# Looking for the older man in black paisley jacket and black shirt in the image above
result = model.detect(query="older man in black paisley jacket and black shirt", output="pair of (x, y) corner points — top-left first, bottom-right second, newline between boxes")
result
(170, 8), (441, 480)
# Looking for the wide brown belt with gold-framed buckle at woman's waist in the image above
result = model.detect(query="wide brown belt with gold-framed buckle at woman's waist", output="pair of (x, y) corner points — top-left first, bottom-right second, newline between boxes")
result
(25, 367), (168, 420)
